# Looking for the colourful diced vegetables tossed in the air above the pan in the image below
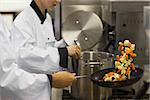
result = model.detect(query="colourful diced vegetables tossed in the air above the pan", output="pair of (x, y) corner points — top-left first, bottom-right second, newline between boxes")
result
(103, 40), (137, 82)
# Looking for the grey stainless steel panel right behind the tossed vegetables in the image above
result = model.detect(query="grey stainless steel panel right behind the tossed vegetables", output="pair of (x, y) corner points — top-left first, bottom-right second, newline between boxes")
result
(116, 12), (148, 64)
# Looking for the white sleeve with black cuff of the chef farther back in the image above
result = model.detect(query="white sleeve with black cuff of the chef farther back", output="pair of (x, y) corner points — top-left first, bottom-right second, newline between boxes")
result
(11, 23), (68, 74)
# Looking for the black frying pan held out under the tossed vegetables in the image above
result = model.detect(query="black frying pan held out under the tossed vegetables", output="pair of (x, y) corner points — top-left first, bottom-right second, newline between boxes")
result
(91, 68), (143, 88)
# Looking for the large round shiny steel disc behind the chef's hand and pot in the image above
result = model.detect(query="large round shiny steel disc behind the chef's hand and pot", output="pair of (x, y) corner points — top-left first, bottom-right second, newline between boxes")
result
(62, 11), (103, 50)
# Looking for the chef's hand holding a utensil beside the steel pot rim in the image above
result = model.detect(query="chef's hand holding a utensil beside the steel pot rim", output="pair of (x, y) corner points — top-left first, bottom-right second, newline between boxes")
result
(67, 45), (81, 59)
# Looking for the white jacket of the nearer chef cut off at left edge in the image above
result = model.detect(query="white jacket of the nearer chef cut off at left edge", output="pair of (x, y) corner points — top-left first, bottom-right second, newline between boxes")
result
(0, 16), (50, 100)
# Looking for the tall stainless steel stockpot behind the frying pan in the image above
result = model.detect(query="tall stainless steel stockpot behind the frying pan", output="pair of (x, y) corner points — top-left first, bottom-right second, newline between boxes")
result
(72, 51), (113, 100)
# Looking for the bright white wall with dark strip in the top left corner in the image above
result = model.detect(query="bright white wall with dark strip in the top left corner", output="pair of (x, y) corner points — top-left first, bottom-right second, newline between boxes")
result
(0, 0), (32, 26)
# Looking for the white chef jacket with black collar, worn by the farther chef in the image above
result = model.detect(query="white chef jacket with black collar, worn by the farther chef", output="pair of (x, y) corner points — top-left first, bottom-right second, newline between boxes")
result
(11, 0), (68, 74)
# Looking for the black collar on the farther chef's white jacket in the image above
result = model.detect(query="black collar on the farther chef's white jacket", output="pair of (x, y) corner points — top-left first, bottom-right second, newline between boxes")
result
(30, 0), (47, 24)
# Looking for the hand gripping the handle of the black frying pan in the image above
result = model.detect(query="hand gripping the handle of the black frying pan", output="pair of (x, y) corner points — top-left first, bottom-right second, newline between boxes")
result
(52, 71), (76, 88)
